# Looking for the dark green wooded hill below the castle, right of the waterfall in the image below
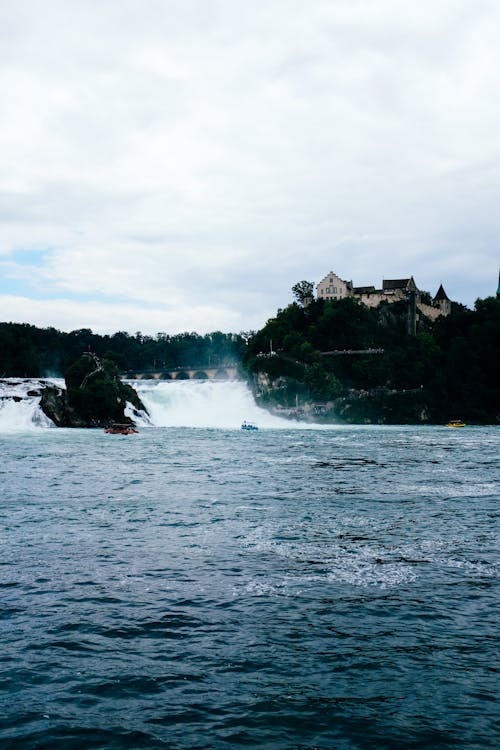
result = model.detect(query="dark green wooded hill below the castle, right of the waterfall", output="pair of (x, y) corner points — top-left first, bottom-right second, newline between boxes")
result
(244, 297), (500, 424)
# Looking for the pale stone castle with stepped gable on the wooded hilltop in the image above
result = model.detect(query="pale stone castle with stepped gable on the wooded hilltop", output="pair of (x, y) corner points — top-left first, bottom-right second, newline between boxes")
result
(316, 271), (451, 320)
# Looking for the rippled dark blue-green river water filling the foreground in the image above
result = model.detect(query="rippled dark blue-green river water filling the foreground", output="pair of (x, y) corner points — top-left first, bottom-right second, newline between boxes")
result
(0, 428), (500, 750)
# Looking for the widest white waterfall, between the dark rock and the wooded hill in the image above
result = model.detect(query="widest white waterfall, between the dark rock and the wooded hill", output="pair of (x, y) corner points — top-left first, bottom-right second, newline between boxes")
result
(135, 380), (294, 429)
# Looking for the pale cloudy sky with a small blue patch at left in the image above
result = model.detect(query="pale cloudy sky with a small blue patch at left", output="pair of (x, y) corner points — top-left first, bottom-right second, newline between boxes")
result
(0, 0), (500, 335)
